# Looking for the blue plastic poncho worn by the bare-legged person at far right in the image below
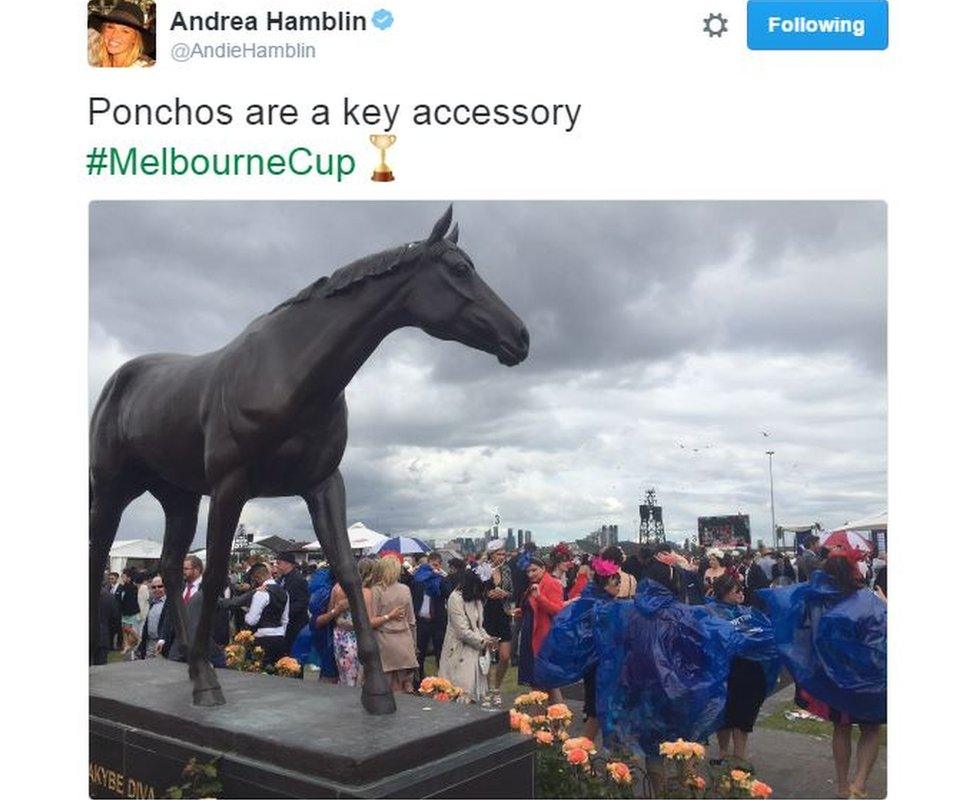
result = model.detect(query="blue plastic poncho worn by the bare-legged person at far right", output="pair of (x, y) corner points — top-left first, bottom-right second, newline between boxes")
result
(758, 570), (888, 722)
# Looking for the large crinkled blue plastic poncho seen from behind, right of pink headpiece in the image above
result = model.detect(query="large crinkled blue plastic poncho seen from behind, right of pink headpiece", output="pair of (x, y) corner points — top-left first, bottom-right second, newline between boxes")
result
(597, 580), (755, 755)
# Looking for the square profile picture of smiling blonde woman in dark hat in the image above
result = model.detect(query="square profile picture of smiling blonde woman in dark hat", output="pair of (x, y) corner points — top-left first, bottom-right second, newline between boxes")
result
(88, 0), (156, 67)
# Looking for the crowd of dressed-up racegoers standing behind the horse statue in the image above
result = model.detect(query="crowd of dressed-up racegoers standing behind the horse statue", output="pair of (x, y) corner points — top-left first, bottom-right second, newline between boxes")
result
(101, 538), (887, 796)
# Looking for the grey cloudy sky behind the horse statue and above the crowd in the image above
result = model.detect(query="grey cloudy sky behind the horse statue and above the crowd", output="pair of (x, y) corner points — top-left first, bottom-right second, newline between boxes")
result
(89, 202), (887, 543)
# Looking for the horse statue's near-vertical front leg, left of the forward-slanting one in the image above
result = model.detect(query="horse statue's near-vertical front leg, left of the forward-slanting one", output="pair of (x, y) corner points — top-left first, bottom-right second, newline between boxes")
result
(188, 473), (247, 706)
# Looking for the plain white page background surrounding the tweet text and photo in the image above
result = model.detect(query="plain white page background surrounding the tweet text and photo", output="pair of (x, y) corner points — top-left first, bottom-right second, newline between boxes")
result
(0, 0), (976, 797)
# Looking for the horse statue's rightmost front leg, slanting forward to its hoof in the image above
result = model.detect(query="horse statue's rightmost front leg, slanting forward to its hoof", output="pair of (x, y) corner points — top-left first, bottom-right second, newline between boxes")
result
(304, 470), (396, 714)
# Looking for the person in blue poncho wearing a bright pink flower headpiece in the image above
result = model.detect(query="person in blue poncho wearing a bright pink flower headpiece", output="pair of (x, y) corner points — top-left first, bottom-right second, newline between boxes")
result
(535, 557), (620, 740)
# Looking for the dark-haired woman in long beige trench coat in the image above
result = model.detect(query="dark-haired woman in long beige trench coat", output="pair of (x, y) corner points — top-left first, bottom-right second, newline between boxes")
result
(438, 570), (498, 703)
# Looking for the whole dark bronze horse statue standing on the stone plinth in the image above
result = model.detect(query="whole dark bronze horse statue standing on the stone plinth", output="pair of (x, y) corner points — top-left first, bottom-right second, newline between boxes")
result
(89, 208), (529, 714)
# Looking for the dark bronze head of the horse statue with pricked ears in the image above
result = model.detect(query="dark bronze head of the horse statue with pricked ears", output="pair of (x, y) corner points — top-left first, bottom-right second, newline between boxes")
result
(403, 207), (529, 367)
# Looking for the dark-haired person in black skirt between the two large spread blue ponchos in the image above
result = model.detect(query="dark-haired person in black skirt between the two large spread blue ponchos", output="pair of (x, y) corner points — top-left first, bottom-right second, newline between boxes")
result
(705, 573), (780, 759)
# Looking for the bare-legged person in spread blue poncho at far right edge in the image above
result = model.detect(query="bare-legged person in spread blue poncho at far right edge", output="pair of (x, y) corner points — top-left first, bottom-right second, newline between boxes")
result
(759, 549), (888, 797)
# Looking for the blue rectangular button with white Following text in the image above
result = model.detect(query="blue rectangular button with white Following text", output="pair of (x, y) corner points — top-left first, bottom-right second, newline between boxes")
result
(747, 0), (888, 50)
